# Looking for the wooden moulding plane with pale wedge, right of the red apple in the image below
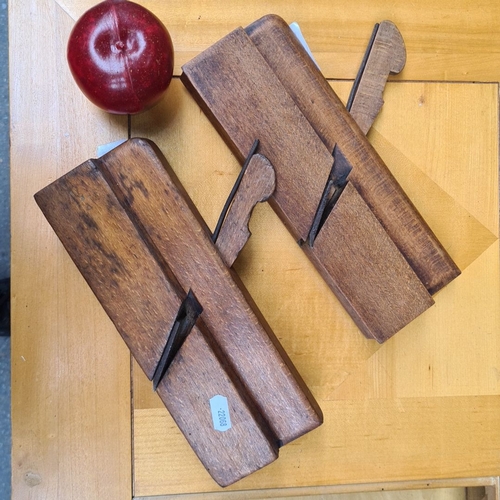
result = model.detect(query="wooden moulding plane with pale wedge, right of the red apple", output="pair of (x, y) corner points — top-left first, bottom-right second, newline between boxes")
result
(181, 15), (460, 342)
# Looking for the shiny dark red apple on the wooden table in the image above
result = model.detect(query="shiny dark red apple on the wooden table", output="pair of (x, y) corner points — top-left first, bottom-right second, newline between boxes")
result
(67, 0), (174, 114)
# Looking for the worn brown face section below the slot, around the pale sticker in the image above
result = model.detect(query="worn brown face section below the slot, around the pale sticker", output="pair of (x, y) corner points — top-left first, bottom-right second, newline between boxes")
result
(157, 321), (279, 486)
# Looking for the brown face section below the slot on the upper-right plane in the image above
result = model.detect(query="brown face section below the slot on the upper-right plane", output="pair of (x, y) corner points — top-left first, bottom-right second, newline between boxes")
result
(304, 183), (434, 343)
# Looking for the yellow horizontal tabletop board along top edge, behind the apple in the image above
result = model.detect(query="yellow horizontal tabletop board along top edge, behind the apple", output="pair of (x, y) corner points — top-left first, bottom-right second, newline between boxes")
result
(57, 0), (500, 82)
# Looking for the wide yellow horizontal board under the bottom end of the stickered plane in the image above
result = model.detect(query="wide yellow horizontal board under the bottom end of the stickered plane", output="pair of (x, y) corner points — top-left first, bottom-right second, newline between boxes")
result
(134, 397), (500, 498)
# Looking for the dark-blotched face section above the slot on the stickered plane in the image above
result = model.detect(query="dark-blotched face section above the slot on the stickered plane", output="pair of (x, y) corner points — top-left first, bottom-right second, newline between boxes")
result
(35, 160), (178, 379)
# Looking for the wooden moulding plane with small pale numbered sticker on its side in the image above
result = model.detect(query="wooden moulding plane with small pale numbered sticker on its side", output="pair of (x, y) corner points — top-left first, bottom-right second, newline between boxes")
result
(35, 139), (322, 486)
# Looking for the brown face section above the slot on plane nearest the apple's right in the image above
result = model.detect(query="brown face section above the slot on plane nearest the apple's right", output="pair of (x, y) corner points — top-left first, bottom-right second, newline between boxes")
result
(181, 29), (333, 241)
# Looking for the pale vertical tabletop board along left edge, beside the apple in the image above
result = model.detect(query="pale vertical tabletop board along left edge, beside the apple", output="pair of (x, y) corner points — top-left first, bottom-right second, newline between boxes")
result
(9, 0), (131, 500)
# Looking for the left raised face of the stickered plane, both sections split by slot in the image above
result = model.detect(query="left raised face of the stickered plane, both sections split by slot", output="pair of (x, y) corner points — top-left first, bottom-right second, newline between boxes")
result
(35, 154), (278, 486)
